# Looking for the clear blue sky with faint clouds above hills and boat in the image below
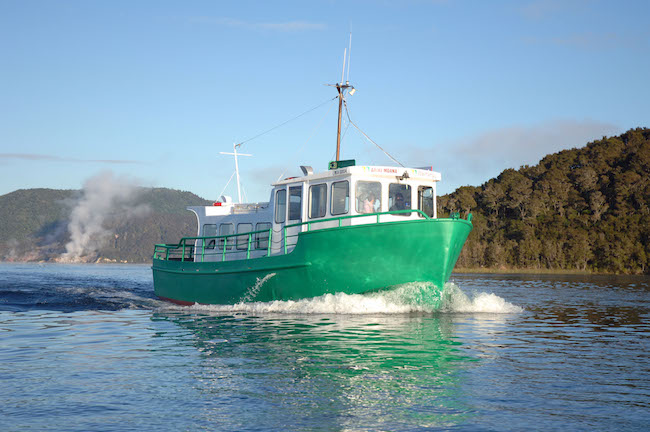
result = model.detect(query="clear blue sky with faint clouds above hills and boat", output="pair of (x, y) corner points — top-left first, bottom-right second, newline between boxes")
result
(0, 0), (650, 201)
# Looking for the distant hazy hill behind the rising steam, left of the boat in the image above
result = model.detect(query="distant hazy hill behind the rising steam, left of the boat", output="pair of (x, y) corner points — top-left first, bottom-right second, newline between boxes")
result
(0, 188), (210, 263)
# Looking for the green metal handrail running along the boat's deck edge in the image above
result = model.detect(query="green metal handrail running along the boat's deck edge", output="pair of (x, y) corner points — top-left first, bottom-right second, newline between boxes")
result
(153, 209), (471, 262)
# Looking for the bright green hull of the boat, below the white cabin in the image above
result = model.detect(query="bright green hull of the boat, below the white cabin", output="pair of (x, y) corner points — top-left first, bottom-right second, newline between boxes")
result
(152, 219), (472, 304)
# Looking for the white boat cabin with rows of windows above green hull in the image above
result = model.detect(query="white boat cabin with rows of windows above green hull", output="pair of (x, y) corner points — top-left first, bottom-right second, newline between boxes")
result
(187, 161), (441, 261)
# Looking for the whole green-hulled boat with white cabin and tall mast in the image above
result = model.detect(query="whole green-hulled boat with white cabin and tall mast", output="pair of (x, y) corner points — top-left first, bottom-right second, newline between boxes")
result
(152, 63), (472, 305)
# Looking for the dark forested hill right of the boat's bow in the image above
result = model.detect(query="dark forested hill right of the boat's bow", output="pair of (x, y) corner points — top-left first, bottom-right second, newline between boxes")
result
(439, 128), (650, 274)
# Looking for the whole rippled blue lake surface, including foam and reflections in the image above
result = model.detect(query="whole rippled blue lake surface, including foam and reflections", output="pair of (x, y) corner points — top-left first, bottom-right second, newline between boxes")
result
(0, 264), (650, 431)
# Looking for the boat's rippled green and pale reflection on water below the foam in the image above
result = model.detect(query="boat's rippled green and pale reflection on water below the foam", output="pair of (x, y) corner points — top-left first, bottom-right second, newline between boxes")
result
(153, 312), (472, 430)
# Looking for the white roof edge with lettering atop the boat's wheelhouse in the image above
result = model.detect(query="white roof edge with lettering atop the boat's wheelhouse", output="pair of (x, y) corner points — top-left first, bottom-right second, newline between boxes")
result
(272, 165), (441, 186)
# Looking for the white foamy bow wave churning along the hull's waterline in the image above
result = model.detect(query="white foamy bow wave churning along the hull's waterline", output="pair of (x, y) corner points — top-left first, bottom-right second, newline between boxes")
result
(167, 281), (523, 315)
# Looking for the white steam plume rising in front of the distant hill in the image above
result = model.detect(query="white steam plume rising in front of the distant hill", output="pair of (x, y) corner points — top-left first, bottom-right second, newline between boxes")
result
(61, 171), (149, 262)
